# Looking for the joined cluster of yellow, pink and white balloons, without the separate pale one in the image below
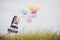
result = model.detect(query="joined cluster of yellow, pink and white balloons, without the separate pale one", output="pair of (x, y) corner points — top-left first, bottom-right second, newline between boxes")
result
(27, 6), (40, 23)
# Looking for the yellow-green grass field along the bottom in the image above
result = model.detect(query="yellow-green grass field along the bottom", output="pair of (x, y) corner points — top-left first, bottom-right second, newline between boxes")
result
(0, 32), (60, 40)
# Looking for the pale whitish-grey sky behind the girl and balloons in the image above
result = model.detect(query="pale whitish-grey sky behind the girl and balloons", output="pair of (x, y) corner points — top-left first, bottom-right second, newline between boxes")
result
(0, 0), (60, 34)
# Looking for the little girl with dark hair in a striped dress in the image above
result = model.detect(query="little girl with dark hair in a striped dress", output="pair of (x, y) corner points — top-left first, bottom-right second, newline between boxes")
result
(8, 16), (19, 33)
